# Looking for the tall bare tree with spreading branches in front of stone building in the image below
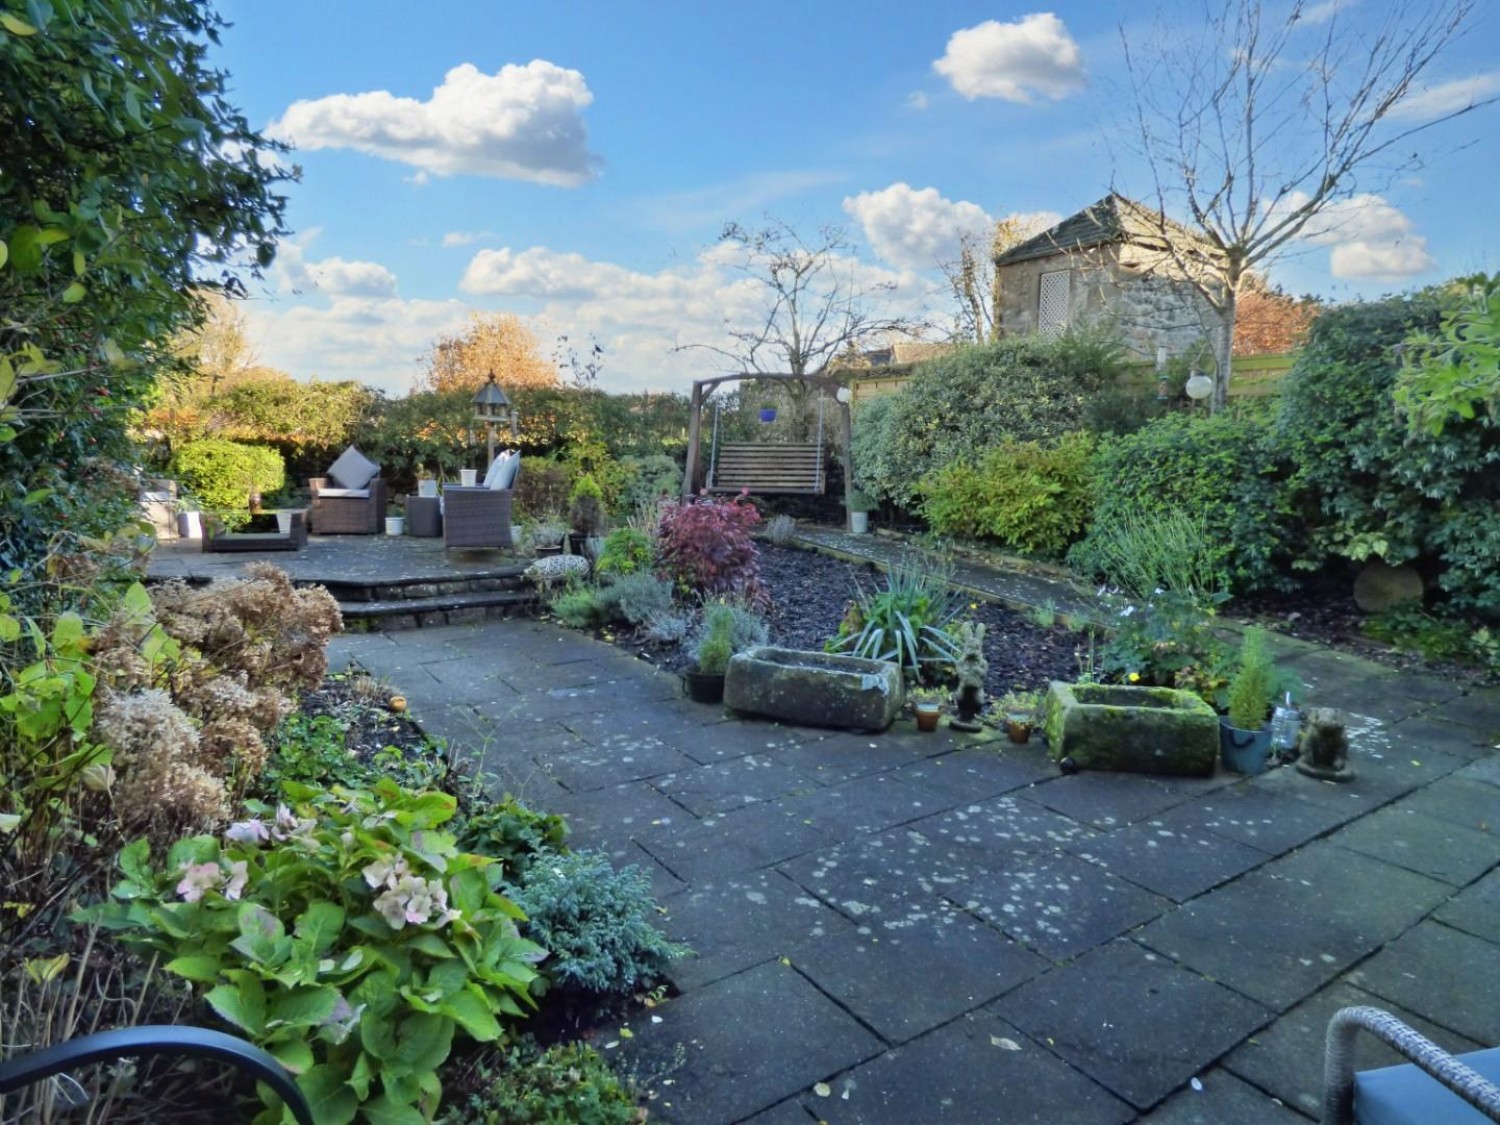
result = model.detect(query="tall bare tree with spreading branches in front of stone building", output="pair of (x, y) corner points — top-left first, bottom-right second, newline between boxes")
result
(1121, 0), (1496, 410)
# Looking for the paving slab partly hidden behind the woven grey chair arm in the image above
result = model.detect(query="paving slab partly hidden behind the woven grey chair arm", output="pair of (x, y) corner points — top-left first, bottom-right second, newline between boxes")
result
(1224, 981), (1475, 1118)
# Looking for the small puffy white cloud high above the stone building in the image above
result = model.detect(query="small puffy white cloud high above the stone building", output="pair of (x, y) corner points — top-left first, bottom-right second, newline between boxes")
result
(933, 12), (1086, 104)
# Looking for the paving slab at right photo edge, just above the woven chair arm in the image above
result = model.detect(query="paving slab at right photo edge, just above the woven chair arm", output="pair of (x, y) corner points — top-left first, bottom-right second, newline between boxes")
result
(1349, 921), (1500, 1046)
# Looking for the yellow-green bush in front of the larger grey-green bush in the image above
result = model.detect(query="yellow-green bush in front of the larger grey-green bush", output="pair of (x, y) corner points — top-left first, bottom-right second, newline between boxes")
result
(920, 434), (1094, 555)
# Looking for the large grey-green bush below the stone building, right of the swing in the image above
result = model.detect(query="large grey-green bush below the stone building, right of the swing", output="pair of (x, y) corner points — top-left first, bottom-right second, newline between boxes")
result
(852, 332), (1122, 509)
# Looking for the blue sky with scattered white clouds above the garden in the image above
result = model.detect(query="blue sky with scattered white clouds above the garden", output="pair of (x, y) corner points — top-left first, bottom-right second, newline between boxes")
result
(215, 0), (1500, 395)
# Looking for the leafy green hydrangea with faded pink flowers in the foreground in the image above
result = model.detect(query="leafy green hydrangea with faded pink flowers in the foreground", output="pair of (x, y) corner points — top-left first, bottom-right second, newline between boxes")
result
(78, 780), (546, 1125)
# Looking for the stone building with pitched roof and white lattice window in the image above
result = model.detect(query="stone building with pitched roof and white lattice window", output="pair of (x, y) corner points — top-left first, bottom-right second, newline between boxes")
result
(995, 194), (1223, 360)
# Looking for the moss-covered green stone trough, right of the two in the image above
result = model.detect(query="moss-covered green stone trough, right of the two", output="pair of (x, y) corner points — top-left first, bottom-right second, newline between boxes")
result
(1041, 680), (1218, 777)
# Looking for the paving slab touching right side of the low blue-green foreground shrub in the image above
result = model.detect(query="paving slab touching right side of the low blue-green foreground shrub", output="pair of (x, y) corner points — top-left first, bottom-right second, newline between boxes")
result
(662, 870), (854, 990)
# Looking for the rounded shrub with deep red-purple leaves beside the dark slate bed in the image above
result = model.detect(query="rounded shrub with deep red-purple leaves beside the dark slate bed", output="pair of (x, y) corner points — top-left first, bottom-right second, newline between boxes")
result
(657, 492), (764, 602)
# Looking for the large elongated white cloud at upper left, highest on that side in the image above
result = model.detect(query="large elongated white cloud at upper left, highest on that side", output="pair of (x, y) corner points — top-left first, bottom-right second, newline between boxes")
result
(269, 59), (597, 186)
